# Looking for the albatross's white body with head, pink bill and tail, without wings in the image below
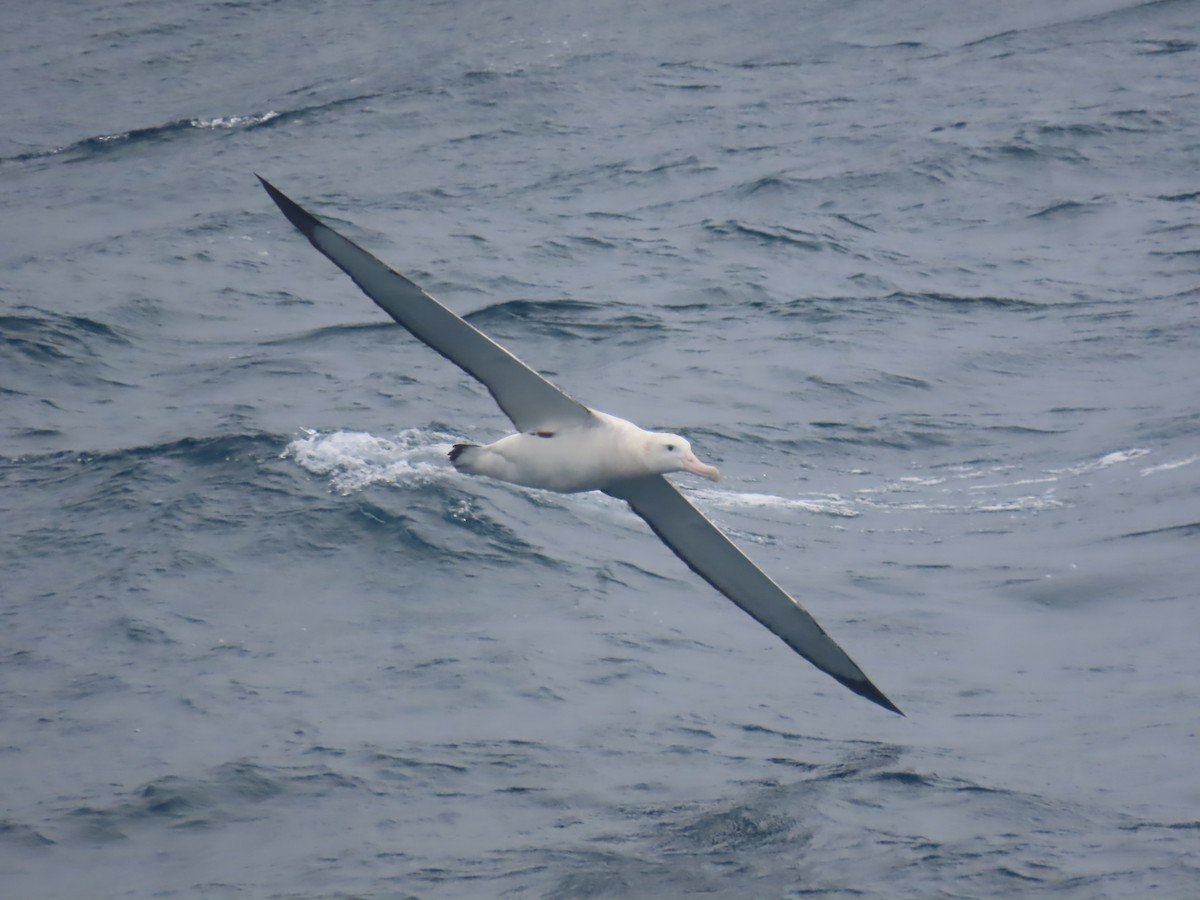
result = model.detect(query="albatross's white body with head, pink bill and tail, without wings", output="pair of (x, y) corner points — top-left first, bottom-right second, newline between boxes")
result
(450, 409), (720, 493)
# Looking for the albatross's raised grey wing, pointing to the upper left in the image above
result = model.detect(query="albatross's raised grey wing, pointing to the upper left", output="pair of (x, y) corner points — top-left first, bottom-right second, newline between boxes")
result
(258, 175), (595, 431)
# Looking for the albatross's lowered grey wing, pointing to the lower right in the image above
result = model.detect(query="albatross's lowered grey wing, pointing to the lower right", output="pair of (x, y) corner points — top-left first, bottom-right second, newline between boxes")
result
(605, 475), (904, 715)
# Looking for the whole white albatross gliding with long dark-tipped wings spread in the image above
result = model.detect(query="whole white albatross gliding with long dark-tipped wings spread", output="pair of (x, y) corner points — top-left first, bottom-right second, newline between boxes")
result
(257, 175), (904, 715)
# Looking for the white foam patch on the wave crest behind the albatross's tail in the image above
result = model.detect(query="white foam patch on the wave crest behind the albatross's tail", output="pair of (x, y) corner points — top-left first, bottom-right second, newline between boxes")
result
(280, 428), (455, 494)
